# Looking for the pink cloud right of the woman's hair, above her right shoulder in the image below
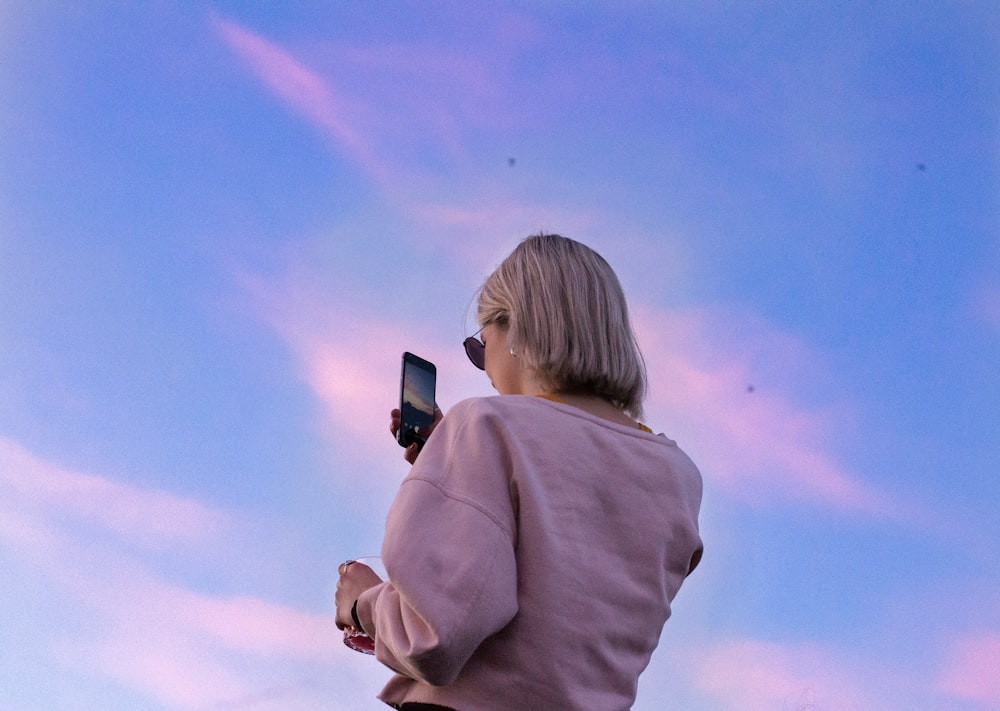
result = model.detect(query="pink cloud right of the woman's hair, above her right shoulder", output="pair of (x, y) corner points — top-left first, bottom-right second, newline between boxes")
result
(637, 310), (900, 515)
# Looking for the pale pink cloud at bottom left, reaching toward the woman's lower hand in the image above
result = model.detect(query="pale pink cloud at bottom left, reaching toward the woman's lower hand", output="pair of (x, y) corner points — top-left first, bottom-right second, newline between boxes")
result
(55, 564), (347, 708)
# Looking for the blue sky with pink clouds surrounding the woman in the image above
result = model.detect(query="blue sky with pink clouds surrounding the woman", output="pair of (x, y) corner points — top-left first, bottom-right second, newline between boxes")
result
(0, 0), (1000, 711)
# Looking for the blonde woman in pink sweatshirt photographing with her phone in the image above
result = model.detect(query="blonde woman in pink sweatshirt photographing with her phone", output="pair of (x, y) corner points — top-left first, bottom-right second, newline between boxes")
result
(337, 235), (702, 711)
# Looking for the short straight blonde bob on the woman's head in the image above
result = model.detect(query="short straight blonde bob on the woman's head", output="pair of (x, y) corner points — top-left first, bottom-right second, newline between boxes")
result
(476, 234), (646, 419)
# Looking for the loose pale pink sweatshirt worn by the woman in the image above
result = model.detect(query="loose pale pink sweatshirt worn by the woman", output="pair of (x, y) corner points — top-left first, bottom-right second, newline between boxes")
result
(357, 395), (702, 711)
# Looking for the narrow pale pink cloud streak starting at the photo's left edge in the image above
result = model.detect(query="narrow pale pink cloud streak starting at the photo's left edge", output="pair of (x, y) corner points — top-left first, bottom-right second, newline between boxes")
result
(0, 437), (228, 545)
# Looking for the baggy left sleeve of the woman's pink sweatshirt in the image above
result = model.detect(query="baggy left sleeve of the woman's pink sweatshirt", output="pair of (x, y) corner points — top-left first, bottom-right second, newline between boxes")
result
(358, 404), (517, 685)
